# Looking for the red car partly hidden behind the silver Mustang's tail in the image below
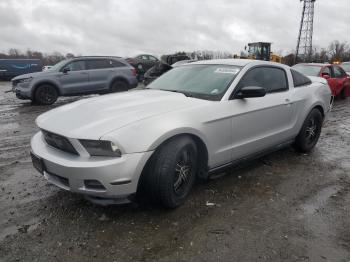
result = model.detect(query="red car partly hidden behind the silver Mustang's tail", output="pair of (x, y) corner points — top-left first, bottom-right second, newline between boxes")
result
(293, 63), (350, 98)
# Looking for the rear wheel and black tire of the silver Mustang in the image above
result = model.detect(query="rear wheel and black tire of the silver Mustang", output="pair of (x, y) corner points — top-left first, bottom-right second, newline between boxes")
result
(294, 108), (323, 153)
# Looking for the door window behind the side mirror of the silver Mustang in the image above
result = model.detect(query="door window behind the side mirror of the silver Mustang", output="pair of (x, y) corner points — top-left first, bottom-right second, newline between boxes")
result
(238, 67), (288, 93)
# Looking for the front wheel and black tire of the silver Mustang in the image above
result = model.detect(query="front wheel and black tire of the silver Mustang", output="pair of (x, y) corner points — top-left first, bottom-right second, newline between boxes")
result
(145, 136), (198, 208)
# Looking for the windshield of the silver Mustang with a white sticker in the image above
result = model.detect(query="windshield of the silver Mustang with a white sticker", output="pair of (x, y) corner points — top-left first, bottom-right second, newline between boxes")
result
(148, 65), (241, 100)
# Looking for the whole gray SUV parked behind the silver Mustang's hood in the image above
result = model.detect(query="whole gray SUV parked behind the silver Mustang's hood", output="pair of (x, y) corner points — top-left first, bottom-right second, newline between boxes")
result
(11, 56), (137, 105)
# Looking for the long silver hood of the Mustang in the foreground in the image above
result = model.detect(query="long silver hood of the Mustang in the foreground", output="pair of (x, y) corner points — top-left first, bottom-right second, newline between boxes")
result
(36, 90), (208, 139)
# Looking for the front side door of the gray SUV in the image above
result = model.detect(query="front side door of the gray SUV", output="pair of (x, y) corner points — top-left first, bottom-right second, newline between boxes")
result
(58, 60), (89, 94)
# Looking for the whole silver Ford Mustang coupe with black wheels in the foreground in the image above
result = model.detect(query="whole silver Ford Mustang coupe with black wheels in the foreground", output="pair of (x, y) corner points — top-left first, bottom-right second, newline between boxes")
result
(31, 59), (331, 208)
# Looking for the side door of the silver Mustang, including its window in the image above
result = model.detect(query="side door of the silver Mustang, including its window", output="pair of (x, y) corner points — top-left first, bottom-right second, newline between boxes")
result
(231, 66), (295, 160)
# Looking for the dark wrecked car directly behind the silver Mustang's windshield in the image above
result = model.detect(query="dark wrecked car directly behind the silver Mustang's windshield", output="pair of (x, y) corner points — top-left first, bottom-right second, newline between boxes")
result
(143, 54), (193, 86)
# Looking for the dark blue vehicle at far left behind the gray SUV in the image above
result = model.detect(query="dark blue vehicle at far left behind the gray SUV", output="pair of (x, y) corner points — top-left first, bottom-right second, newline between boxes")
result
(0, 59), (42, 80)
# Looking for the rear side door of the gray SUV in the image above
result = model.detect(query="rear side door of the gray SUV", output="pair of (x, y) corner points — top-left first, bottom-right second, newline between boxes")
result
(87, 58), (114, 92)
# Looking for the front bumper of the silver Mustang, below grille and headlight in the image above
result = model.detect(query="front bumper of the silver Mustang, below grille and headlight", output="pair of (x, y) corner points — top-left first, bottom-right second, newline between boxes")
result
(31, 132), (153, 198)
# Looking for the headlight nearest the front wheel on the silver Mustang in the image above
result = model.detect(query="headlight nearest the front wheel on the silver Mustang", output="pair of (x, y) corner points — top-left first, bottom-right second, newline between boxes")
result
(79, 139), (122, 157)
